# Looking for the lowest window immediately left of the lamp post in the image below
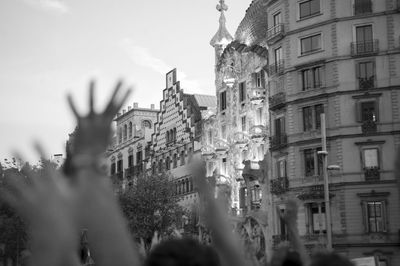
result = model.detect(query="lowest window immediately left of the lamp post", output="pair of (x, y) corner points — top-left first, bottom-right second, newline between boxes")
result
(306, 202), (326, 234)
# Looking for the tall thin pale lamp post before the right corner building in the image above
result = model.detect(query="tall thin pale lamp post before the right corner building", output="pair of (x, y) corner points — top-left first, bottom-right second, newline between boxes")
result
(318, 113), (332, 250)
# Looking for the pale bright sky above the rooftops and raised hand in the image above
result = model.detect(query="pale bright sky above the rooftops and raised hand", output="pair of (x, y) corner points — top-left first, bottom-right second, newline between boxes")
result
(0, 0), (251, 162)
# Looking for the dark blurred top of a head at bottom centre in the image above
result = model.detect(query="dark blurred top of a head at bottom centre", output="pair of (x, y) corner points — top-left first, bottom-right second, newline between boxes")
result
(145, 238), (220, 266)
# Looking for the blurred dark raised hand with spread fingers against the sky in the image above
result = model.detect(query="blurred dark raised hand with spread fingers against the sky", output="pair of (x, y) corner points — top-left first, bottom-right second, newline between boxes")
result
(68, 81), (131, 156)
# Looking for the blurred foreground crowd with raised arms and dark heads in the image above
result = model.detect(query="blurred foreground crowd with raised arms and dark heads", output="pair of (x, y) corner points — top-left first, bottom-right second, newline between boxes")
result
(0, 82), (353, 266)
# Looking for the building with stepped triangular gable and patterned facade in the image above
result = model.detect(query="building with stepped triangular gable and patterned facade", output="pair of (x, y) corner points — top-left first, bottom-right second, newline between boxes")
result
(150, 69), (216, 210)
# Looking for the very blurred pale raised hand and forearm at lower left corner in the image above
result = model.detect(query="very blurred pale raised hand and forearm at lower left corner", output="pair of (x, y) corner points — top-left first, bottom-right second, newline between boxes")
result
(0, 148), (79, 265)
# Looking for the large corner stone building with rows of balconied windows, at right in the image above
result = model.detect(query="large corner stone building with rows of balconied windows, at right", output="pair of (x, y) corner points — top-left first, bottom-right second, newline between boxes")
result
(263, 0), (400, 265)
